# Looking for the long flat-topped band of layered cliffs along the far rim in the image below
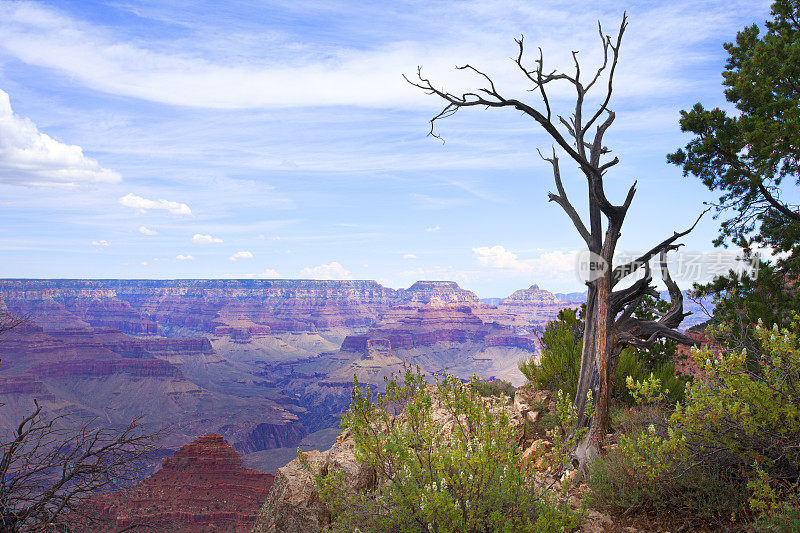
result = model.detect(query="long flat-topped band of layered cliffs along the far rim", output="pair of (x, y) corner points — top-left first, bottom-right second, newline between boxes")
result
(0, 279), (478, 338)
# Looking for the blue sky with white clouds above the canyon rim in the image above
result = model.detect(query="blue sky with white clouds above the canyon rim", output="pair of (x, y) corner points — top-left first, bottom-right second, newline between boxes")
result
(0, 0), (769, 297)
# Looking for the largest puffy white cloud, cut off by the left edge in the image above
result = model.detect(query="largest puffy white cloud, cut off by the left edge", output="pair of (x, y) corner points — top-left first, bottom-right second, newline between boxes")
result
(0, 90), (122, 187)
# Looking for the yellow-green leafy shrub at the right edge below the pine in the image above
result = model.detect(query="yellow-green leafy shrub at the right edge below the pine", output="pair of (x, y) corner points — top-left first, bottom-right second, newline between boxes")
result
(670, 317), (800, 483)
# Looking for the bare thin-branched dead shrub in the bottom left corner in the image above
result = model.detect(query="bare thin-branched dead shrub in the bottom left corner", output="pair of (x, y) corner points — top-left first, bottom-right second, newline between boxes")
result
(0, 400), (162, 532)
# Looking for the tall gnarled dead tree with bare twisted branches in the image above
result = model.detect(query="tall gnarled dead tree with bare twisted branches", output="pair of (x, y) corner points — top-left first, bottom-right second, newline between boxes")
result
(406, 15), (702, 466)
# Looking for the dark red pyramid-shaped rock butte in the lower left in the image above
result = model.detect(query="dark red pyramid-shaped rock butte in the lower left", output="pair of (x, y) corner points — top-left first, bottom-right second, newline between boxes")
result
(92, 434), (273, 532)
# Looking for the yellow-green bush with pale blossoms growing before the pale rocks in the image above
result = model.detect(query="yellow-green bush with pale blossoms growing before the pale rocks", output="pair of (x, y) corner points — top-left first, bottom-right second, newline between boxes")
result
(304, 370), (577, 532)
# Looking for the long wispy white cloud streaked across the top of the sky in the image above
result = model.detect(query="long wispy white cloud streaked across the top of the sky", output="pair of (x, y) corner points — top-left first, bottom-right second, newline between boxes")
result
(0, 2), (760, 108)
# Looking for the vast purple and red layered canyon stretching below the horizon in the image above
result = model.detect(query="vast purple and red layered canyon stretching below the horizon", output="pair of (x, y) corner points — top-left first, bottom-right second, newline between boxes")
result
(0, 279), (580, 531)
